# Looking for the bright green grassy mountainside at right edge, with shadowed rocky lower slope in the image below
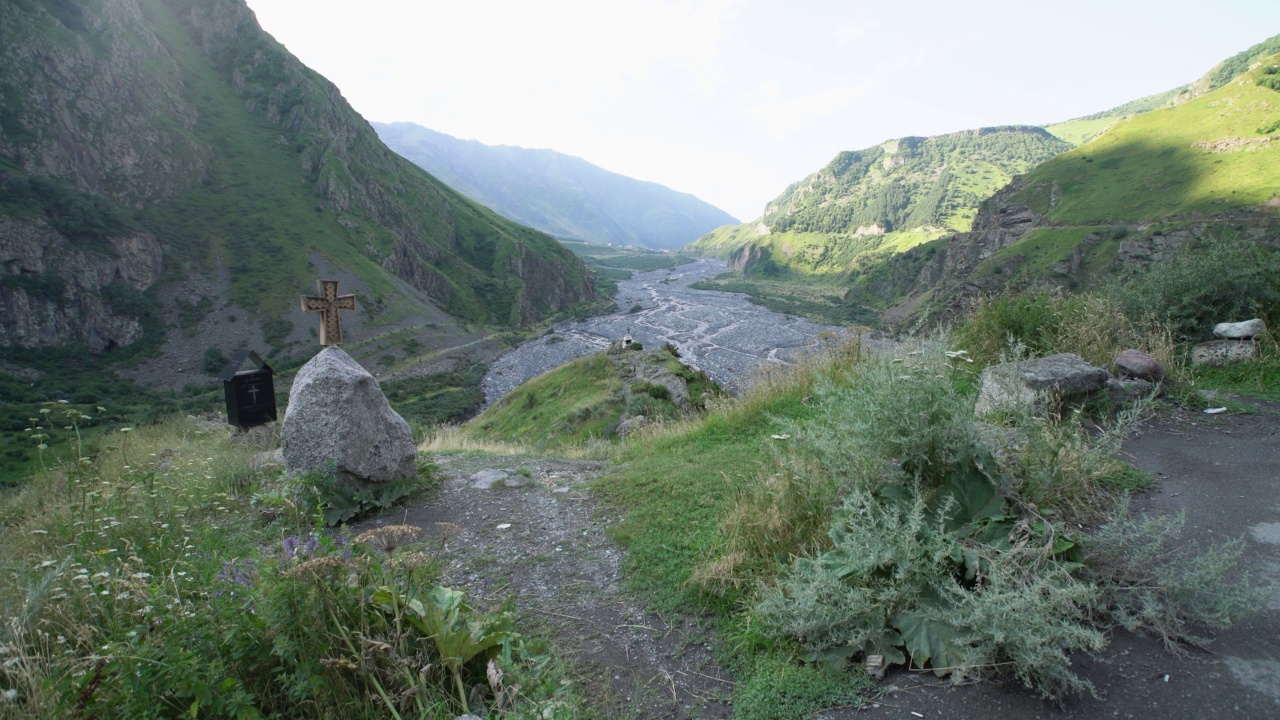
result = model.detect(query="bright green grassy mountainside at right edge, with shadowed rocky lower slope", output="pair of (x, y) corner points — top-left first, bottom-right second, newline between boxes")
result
(846, 45), (1280, 319)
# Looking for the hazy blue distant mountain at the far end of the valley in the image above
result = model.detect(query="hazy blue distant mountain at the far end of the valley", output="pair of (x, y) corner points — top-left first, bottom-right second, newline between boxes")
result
(374, 123), (737, 249)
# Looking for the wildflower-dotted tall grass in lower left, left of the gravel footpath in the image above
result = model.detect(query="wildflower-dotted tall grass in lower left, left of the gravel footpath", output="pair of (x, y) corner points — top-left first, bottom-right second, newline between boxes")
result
(0, 405), (580, 720)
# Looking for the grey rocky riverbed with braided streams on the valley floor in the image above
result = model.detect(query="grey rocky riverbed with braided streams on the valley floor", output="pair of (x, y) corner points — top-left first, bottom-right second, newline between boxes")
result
(484, 259), (855, 404)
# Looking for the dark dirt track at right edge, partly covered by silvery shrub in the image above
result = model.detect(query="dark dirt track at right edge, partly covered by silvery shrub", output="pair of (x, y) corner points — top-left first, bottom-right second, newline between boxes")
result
(824, 401), (1280, 720)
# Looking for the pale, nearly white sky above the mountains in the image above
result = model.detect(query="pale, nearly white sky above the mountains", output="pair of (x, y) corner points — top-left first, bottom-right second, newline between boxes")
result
(241, 0), (1280, 220)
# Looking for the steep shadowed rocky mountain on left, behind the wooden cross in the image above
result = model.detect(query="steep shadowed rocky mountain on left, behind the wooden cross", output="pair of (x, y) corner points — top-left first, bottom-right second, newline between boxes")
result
(0, 0), (595, 352)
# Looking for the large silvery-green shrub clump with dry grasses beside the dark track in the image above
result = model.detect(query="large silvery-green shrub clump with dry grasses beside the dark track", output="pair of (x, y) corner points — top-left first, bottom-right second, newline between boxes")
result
(727, 341), (1258, 697)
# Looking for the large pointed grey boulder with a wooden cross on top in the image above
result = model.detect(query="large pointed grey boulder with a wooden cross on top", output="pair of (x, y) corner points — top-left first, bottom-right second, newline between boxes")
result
(280, 346), (417, 483)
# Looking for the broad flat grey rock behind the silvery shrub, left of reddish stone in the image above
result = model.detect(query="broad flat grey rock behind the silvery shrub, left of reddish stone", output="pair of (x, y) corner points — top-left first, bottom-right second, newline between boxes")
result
(974, 352), (1111, 415)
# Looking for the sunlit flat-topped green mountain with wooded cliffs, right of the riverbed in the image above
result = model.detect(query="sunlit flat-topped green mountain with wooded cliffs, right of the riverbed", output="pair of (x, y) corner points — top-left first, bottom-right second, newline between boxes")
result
(690, 126), (1071, 322)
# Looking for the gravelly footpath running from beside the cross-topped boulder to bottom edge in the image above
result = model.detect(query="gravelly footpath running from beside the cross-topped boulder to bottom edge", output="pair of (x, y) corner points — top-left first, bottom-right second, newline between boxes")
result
(362, 455), (732, 719)
